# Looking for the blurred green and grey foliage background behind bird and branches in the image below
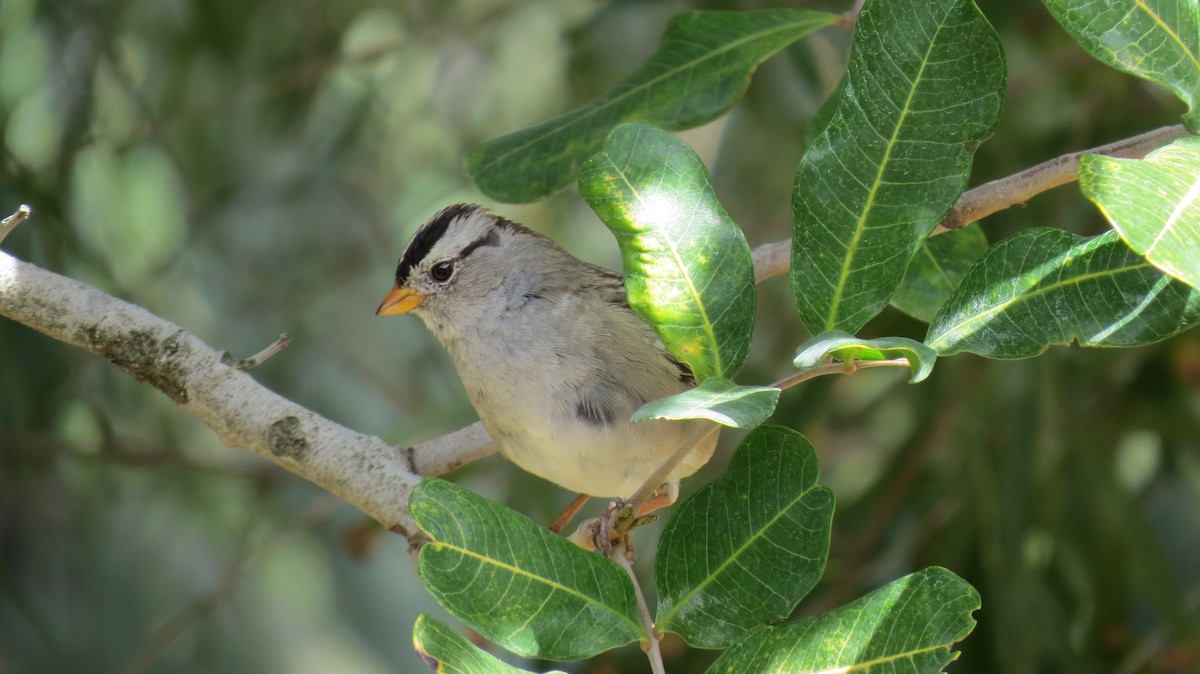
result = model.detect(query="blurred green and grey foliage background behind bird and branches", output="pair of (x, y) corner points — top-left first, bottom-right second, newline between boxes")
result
(0, 0), (1200, 673)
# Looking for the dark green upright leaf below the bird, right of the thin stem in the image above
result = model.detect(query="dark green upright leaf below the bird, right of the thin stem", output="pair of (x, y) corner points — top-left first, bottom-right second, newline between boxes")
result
(654, 426), (834, 649)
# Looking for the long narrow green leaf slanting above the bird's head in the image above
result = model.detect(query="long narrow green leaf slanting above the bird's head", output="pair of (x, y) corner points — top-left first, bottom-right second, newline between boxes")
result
(467, 8), (839, 203)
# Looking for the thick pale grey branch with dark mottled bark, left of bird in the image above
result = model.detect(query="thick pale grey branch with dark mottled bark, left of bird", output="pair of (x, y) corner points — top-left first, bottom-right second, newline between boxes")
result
(0, 243), (448, 543)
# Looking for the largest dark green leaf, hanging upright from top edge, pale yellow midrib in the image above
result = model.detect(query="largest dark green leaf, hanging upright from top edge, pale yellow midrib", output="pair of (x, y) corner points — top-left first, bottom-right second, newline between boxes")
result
(791, 0), (1006, 333)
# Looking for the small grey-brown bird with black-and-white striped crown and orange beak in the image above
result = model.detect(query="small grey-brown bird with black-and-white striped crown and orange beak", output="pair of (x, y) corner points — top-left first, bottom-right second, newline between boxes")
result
(376, 204), (716, 526)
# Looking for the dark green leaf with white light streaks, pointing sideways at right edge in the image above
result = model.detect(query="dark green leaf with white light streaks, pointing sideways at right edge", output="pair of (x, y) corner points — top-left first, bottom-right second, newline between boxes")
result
(925, 228), (1200, 359)
